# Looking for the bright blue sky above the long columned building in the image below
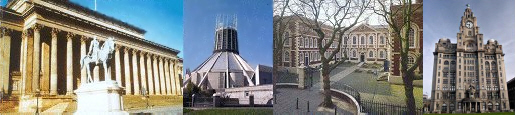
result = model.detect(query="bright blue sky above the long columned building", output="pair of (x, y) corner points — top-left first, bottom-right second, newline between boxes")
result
(0, 0), (184, 57)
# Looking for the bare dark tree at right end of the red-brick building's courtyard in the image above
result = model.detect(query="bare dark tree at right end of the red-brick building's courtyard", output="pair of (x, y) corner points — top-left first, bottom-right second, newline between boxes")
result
(374, 0), (422, 115)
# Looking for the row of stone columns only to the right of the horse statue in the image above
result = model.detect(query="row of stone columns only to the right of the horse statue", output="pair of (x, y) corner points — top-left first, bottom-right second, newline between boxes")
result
(114, 46), (181, 95)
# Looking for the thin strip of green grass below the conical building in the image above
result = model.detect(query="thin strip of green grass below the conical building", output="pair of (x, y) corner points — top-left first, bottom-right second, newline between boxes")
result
(183, 108), (273, 115)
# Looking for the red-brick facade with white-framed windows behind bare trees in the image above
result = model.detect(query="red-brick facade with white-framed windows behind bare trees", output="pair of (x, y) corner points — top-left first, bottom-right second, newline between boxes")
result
(280, 16), (390, 67)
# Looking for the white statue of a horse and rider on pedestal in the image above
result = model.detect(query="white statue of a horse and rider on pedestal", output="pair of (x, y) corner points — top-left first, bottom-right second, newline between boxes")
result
(80, 37), (115, 83)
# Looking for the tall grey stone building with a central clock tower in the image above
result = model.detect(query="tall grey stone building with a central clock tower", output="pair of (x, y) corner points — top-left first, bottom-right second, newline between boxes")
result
(430, 7), (510, 113)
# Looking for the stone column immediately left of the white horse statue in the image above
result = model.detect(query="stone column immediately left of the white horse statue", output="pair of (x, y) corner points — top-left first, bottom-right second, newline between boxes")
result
(66, 33), (75, 95)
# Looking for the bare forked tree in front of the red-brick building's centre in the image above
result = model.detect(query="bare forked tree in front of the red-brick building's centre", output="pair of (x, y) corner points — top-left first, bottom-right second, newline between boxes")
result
(286, 0), (371, 108)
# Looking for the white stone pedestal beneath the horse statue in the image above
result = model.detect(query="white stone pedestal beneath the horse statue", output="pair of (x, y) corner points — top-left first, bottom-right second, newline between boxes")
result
(75, 81), (125, 114)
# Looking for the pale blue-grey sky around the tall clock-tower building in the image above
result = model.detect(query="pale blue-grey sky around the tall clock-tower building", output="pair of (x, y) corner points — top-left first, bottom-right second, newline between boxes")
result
(423, 0), (515, 96)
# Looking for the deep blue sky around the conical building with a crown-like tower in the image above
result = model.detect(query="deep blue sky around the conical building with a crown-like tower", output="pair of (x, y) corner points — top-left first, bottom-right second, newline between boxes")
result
(184, 0), (273, 70)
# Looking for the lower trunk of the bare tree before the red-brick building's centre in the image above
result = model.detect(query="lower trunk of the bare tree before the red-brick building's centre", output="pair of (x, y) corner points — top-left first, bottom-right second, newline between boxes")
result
(320, 63), (334, 108)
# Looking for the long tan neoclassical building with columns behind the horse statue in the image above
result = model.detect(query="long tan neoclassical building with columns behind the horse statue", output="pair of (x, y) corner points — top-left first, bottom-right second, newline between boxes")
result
(0, 0), (182, 110)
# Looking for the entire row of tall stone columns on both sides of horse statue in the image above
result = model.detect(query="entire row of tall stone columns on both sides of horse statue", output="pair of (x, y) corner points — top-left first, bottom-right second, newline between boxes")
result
(16, 24), (182, 95)
